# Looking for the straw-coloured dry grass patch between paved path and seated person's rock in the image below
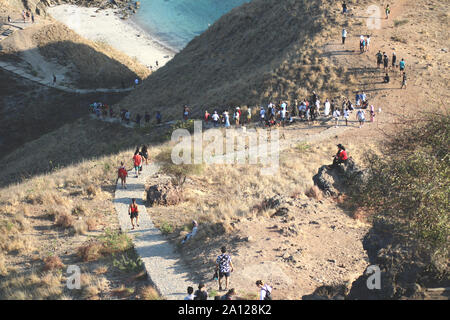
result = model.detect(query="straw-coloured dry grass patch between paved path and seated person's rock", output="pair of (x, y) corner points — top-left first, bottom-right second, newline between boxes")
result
(148, 136), (366, 242)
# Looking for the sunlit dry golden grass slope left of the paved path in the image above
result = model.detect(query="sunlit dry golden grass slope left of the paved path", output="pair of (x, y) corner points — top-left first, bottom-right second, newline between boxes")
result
(0, 145), (162, 299)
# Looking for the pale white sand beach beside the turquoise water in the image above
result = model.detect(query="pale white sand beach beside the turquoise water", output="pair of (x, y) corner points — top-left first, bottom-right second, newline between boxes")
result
(48, 4), (176, 70)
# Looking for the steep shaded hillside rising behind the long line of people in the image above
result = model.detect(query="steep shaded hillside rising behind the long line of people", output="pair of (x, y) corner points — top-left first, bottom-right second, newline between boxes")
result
(118, 0), (360, 119)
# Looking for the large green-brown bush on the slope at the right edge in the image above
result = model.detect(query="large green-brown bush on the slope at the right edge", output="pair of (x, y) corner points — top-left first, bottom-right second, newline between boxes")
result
(352, 114), (450, 268)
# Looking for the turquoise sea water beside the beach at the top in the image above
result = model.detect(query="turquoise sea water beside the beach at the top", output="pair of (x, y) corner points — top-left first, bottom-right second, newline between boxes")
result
(134, 0), (250, 50)
